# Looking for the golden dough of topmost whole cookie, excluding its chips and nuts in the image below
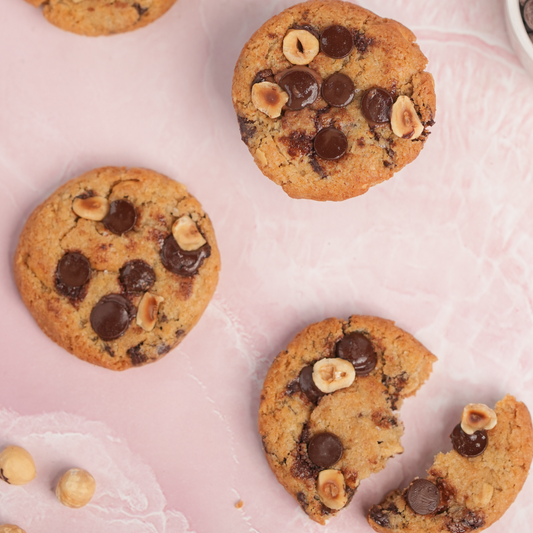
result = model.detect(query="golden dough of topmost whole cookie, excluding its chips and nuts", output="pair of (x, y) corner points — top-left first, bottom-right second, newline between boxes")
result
(232, 0), (436, 201)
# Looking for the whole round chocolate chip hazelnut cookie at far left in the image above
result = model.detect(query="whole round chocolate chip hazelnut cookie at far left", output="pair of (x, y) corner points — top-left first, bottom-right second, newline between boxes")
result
(14, 167), (220, 370)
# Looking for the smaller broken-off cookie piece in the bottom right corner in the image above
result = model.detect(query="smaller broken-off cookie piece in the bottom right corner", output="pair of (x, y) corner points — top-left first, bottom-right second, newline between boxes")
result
(368, 395), (533, 533)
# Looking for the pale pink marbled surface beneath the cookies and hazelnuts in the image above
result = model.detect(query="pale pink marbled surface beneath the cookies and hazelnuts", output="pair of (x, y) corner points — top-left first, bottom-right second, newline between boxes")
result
(0, 0), (533, 533)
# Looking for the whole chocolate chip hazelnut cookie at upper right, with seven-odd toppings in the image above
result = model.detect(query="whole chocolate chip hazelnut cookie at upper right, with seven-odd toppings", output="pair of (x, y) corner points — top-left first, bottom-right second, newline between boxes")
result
(232, 0), (436, 201)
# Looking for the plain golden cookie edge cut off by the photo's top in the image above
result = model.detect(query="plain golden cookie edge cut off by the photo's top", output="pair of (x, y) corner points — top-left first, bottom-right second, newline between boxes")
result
(26, 0), (176, 37)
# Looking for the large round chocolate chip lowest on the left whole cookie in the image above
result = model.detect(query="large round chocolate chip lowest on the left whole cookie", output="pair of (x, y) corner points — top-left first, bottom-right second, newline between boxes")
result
(91, 294), (136, 341)
